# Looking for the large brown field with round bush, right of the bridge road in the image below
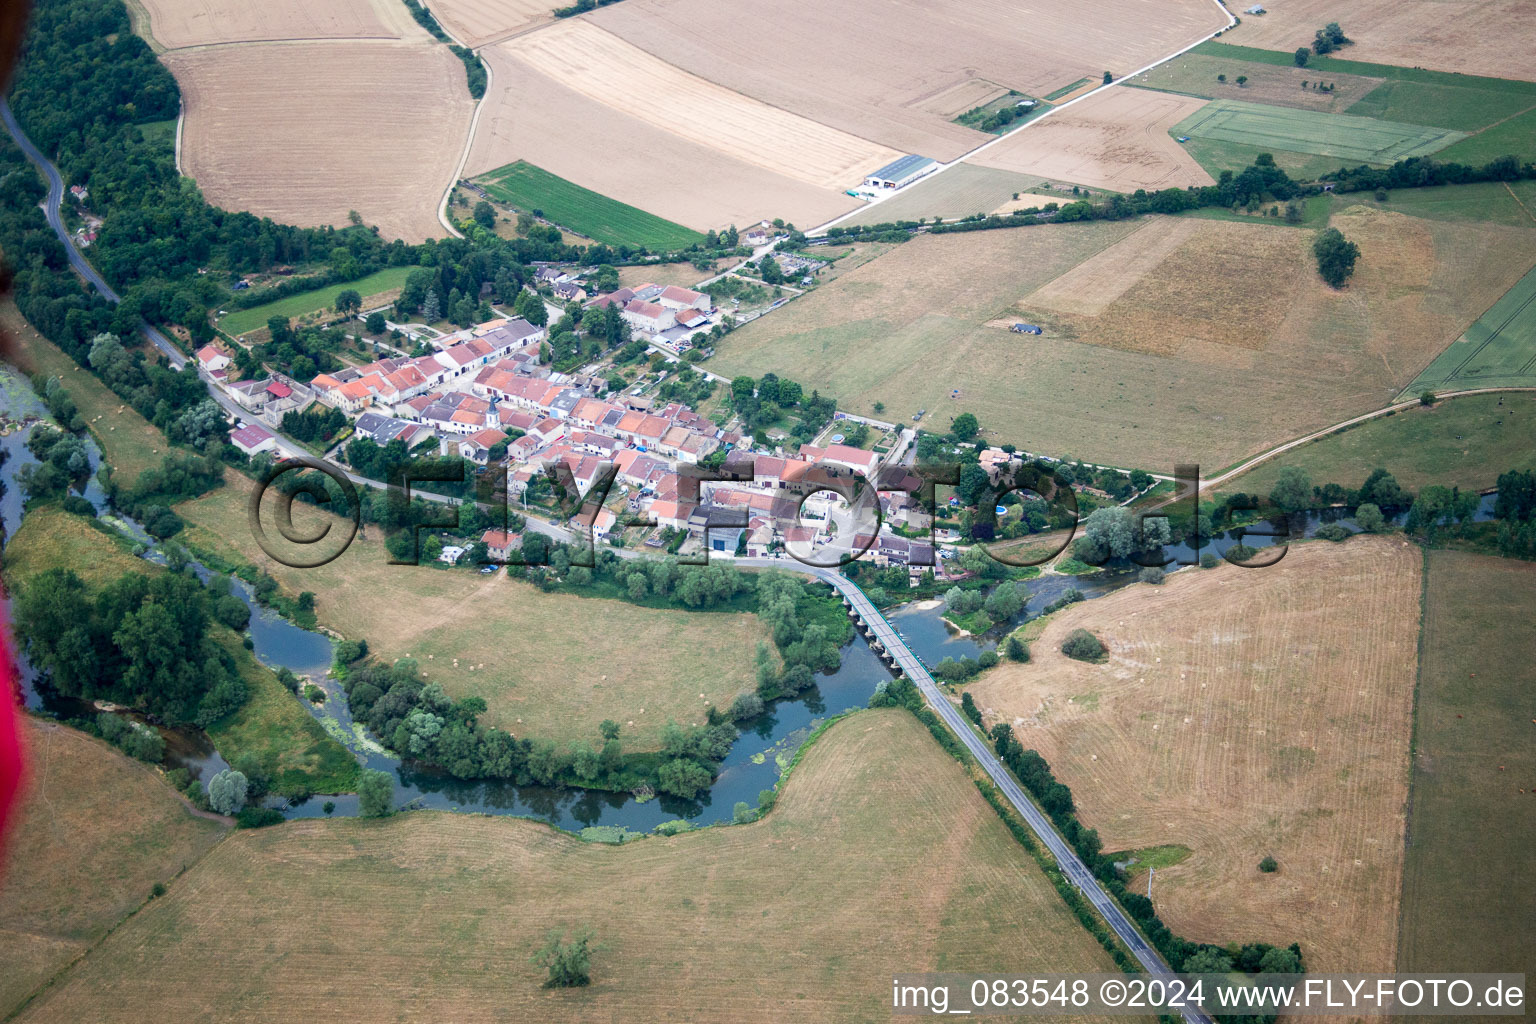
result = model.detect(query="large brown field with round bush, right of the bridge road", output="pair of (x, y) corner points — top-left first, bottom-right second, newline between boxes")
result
(969, 537), (1421, 972)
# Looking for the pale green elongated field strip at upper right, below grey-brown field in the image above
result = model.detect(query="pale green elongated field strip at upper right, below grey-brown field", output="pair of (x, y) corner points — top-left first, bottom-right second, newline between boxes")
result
(1172, 100), (1465, 164)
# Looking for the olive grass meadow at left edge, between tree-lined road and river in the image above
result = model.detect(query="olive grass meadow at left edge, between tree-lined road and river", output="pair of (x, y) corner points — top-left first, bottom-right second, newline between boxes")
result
(0, 299), (170, 484)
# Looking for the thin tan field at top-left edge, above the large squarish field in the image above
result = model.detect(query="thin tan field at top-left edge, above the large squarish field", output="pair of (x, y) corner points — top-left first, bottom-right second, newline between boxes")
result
(138, 0), (427, 49)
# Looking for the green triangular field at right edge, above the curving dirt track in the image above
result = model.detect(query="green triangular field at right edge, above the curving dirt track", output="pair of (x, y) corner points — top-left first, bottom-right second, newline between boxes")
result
(1402, 262), (1536, 396)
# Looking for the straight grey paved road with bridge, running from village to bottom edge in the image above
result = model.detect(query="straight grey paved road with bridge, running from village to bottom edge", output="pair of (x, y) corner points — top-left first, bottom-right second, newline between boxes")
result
(736, 559), (1210, 1024)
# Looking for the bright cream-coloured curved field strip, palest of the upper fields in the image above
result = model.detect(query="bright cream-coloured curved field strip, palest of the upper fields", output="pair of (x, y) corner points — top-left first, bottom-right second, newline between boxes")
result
(505, 18), (900, 189)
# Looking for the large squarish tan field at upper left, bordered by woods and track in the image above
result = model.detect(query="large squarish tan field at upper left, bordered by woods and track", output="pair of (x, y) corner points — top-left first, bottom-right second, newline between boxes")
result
(164, 41), (473, 241)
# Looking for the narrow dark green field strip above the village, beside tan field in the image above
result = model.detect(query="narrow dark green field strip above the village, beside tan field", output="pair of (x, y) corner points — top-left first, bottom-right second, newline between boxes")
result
(476, 160), (703, 250)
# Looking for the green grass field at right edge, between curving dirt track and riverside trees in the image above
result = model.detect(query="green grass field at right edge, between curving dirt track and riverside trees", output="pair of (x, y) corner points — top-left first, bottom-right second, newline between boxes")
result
(1221, 391), (1536, 494)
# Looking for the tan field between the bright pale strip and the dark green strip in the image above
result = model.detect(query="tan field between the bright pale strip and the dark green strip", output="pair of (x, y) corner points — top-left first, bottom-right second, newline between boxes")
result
(459, 40), (860, 230)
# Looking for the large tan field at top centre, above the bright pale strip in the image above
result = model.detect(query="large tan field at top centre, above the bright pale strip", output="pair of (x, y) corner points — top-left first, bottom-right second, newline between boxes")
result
(582, 0), (1224, 160)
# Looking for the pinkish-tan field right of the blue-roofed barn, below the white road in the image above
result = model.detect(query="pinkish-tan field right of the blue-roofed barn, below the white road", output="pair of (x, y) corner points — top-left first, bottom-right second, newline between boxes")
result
(974, 89), (1213, 192)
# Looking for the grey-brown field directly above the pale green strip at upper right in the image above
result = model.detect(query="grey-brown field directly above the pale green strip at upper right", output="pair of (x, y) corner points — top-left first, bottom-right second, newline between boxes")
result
(1126, 52), (1382, 112)
